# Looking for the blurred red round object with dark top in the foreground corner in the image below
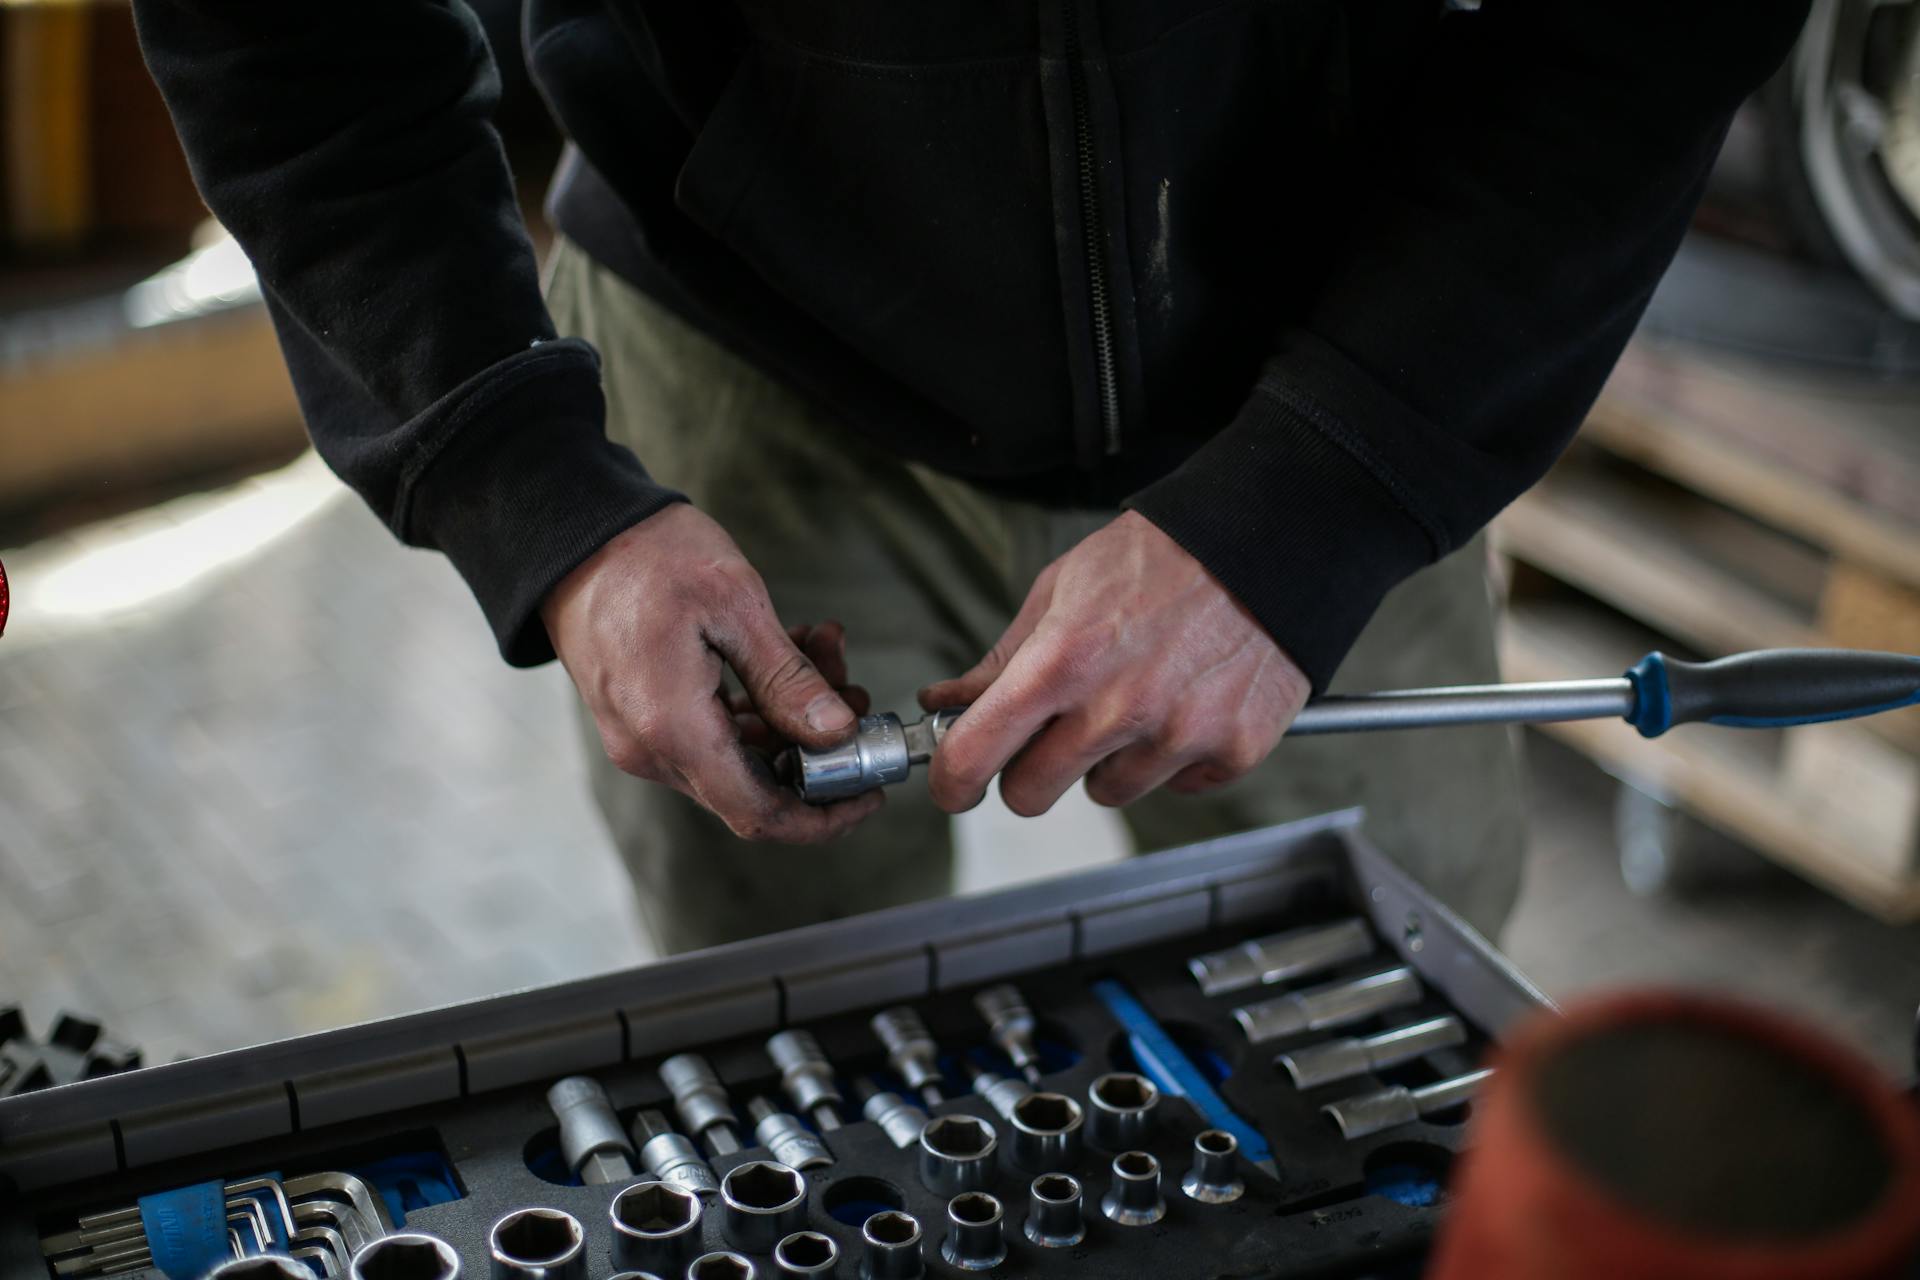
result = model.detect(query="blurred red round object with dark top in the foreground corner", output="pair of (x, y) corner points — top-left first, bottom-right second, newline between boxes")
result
(1427, 992), (1920, 1280)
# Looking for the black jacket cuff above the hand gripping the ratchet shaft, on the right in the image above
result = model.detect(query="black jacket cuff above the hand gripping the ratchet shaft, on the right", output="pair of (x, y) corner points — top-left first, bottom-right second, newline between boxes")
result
(1125, 337), (1450, 693)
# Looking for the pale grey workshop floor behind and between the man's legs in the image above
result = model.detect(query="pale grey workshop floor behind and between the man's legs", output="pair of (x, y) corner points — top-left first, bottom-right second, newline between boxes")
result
(0, 457), (1920, 1071)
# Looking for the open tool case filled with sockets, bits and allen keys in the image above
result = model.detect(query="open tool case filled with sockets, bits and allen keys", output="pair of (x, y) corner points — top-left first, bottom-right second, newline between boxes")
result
(0, 814), (1544, 1280)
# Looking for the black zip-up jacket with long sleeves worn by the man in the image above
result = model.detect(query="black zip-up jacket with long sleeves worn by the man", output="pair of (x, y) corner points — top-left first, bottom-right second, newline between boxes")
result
(134, 0), (1807, 687)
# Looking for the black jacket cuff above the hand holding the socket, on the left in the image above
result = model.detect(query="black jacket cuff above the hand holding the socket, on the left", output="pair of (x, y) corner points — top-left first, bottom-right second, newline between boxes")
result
(394, 340), (685, 666)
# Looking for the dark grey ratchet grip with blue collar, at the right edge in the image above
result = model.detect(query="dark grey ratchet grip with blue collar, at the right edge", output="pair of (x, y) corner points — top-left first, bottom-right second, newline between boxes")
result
(1626, 649), (1920, 737)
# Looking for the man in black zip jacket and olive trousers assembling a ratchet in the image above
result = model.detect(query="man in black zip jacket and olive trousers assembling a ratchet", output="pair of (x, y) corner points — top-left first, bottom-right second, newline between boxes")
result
(134, 0), (1805, 946)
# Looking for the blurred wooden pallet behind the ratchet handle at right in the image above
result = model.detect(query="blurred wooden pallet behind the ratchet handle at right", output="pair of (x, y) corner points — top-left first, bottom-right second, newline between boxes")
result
(1494, 335), (1920, 921)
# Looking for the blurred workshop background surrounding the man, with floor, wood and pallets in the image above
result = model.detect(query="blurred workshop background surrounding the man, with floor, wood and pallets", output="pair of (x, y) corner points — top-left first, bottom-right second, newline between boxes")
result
(0, 0), (1920, 1073)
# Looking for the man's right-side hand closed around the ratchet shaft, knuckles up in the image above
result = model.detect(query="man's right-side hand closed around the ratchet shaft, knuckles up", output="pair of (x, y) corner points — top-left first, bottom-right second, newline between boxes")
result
(920, 510), (1309, 818)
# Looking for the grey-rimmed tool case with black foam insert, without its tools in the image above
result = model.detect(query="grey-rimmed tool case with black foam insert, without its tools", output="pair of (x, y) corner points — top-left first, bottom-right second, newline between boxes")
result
(0, 812), (1548, 1280)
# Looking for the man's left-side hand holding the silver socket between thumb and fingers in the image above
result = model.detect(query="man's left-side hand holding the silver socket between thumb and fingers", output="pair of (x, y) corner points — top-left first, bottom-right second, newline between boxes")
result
(540, 505), (879, 844)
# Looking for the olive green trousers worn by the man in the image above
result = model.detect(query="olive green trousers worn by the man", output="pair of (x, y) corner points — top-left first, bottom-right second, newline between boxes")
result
(547, 242), (1524, 952)
